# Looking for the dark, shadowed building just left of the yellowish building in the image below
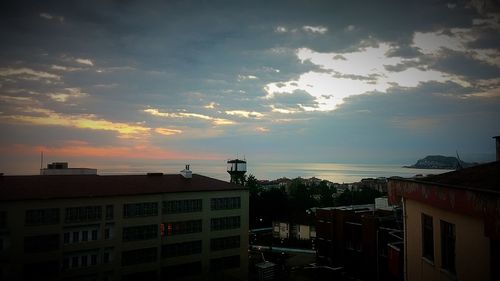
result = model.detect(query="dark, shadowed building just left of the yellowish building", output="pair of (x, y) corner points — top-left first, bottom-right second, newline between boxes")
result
(316, 204), (403, 281)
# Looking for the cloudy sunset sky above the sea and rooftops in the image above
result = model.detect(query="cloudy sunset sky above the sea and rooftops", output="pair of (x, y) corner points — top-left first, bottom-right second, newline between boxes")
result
(0, 0), (500, 174)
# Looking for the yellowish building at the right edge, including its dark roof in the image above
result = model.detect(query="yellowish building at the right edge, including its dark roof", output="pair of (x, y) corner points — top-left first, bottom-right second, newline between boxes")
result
(388, 161), (500, 281)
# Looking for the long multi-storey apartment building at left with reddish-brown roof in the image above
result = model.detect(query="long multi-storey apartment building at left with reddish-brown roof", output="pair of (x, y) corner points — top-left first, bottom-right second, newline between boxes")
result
(0, 170), (248, 280)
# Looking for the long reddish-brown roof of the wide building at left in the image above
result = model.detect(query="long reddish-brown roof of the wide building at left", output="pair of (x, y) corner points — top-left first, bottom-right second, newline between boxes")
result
(0, 174), (246, 201)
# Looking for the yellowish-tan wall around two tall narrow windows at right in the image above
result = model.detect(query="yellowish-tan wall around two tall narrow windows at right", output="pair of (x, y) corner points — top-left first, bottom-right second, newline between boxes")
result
(405, 200), (490, 281)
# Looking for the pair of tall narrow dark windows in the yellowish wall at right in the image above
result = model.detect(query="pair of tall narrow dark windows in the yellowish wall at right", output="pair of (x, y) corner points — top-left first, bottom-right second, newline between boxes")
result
(422, 214), (456, 273)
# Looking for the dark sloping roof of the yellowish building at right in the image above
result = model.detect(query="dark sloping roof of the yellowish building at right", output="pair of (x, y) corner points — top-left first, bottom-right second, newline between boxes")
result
(390, 161), (500, 193)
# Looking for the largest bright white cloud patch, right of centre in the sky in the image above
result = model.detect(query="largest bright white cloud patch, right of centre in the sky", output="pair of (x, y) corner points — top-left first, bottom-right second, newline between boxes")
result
(264, 43), (470, 113)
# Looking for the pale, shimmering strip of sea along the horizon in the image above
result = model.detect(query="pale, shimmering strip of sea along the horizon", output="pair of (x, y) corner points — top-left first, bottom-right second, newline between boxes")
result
(98, 161), (451, 183)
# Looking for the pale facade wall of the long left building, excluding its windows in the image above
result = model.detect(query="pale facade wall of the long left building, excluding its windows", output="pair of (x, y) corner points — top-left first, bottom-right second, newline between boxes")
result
(0, 187), (248, 280)
